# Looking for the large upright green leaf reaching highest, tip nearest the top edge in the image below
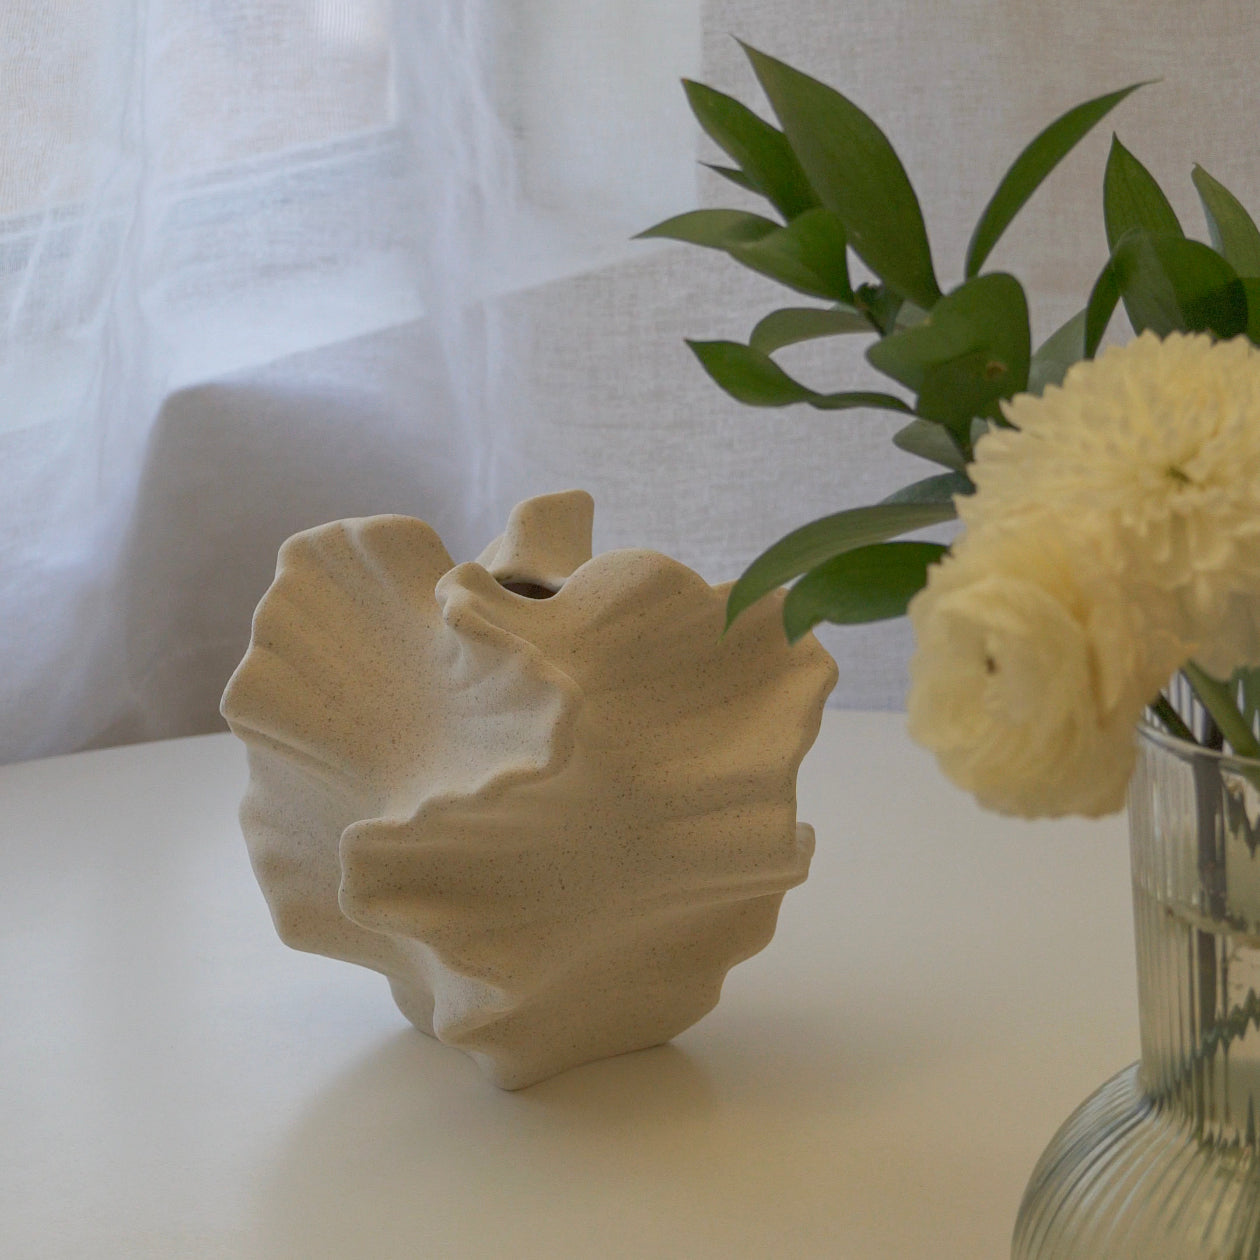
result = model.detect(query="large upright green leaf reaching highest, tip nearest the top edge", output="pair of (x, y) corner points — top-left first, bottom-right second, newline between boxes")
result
(743, 45), (940, 310)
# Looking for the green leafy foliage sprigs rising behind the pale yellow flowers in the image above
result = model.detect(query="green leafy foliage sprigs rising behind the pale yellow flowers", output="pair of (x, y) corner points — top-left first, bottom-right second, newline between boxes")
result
(640, 45), (1260, 755)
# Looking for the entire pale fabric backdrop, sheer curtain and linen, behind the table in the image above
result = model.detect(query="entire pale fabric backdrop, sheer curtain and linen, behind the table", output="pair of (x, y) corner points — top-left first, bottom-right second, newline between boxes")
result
(0, 0), (1260, 761)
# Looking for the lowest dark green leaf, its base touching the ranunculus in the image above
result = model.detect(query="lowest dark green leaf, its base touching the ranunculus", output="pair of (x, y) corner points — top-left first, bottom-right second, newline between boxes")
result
(784, 543), (949, 643)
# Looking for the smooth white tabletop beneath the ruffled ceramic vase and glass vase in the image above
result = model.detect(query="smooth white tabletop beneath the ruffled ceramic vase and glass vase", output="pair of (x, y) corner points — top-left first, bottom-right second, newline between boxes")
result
(0, 712), (1138, 1260)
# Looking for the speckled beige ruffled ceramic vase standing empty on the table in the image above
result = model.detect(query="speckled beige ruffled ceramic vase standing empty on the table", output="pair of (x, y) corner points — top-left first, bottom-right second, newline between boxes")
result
(223, 491), (835, 1089)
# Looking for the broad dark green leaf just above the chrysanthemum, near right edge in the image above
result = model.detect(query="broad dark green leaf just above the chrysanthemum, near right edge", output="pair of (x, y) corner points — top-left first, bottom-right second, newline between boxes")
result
(1111, 228), (1247, 338)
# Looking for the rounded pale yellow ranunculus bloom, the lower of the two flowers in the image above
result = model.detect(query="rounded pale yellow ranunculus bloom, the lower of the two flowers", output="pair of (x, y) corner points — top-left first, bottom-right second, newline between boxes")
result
(908, 518), (1183, 818)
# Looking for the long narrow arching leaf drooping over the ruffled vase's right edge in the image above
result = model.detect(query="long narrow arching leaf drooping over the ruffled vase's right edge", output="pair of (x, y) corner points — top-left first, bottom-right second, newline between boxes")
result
(726, 503), (955, 626)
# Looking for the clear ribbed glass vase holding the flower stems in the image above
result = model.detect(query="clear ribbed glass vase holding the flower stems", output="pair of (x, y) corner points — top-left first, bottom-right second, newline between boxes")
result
(1012, 727), (1260, 1260)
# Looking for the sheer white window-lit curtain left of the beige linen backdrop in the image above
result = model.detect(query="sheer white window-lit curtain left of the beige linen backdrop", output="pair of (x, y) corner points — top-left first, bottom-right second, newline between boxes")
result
(0, 0), (698, 760)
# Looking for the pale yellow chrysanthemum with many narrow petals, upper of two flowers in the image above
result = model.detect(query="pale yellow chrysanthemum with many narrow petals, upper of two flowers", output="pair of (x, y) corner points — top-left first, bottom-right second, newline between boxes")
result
(959, 333), (1260, 675)
